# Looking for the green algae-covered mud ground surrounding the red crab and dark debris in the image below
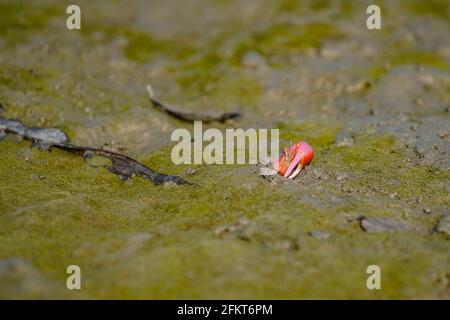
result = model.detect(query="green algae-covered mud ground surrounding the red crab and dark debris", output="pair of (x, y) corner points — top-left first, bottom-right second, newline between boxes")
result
(0, 0), (450, 299)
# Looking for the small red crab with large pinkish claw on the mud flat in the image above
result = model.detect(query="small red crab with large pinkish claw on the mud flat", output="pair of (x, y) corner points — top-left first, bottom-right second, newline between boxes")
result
(273, 141), (314, 179)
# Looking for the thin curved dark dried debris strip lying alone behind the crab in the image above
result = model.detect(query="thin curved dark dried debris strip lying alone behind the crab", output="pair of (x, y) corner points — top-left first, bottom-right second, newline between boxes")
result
(147, 85), (241, 123)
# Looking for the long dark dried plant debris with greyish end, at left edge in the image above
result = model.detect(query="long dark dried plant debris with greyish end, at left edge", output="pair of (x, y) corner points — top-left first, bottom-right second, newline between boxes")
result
(0, 116), (189, 185)
